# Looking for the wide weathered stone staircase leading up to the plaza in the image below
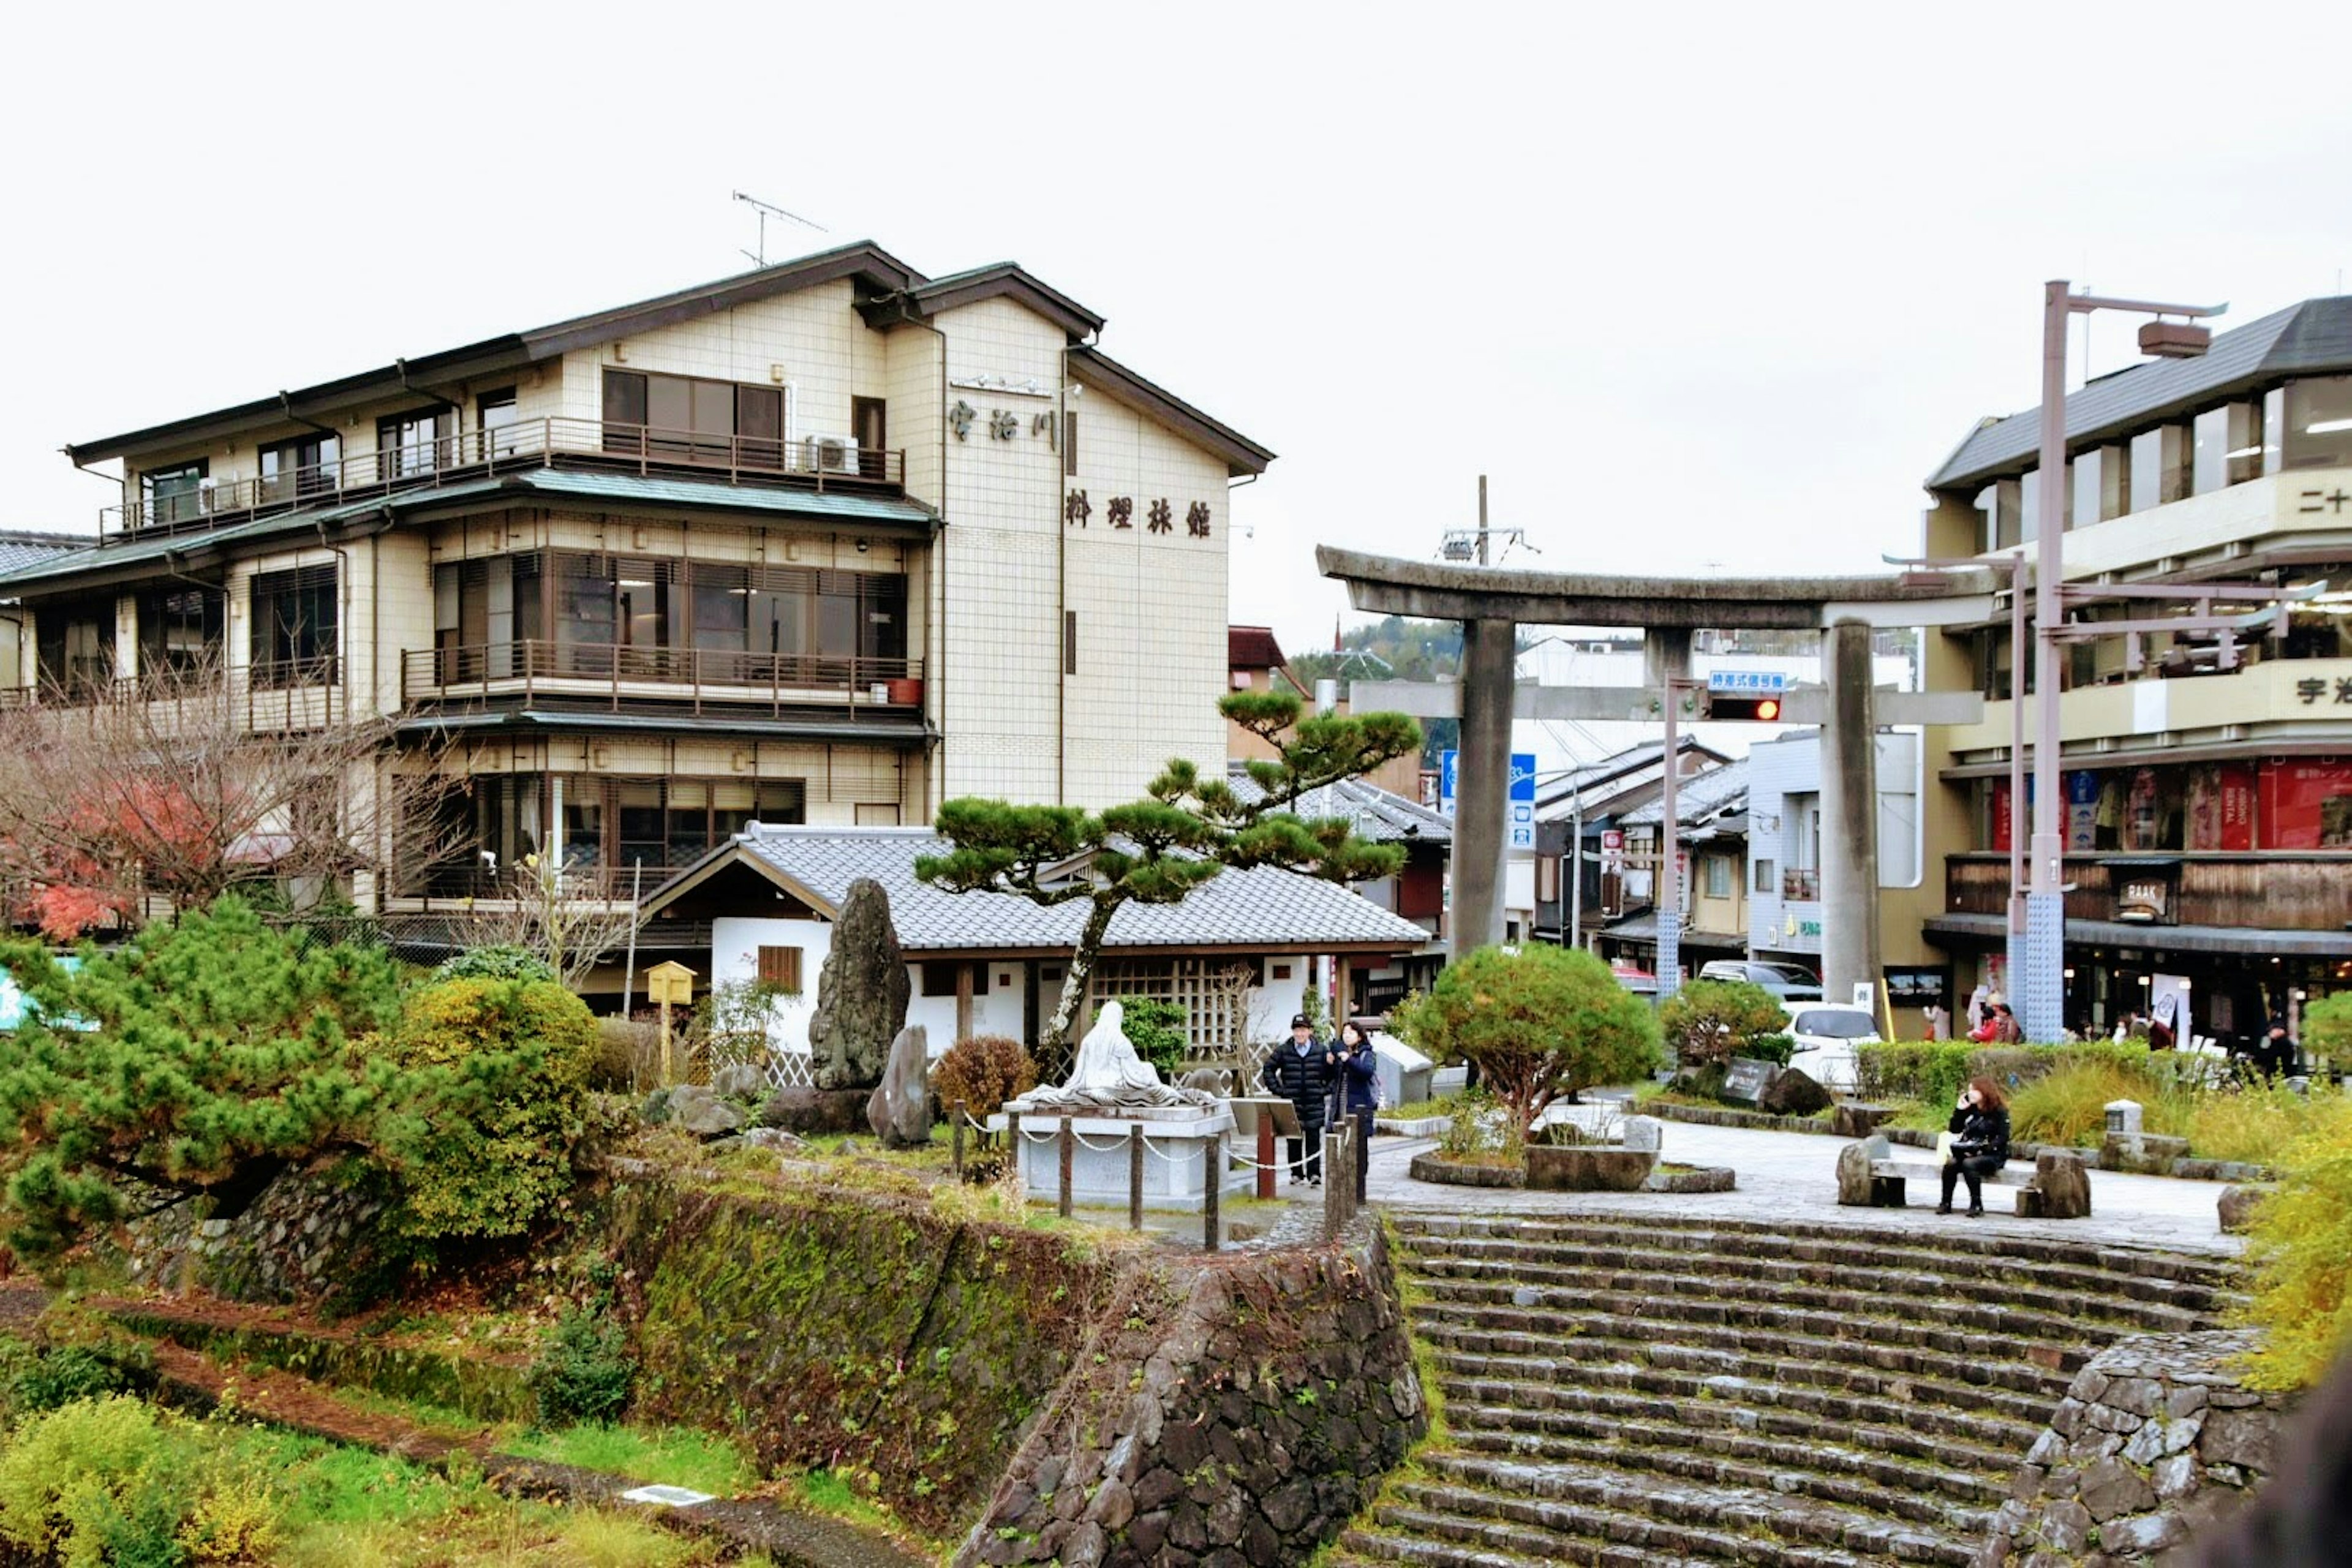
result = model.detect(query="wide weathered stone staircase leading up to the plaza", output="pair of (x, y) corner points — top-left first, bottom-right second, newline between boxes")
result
(1331, 1213), (2234, 1568)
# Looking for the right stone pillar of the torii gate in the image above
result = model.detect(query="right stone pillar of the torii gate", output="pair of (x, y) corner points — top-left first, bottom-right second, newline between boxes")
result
(1820, 620), (1879, 1011)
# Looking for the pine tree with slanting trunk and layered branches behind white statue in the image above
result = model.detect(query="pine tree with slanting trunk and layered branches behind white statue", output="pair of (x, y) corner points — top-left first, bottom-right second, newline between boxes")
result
(915, 691), (1420, 1063)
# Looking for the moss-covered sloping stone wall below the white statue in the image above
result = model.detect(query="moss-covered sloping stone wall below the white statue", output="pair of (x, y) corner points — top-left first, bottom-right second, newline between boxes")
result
(609, 1180), (1117, 1531)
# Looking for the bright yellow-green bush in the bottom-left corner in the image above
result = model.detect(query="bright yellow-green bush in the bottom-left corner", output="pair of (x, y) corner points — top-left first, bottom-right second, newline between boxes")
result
(0, 1394), (200, 1568)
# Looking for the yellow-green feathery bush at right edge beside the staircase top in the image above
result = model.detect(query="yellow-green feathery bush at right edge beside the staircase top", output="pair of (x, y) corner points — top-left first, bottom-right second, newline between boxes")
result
(2246, 1096), (2352, 1389)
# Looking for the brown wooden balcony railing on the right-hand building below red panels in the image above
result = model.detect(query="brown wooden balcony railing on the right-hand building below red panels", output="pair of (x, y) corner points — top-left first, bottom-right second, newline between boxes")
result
(1943, 851), (2352, 948)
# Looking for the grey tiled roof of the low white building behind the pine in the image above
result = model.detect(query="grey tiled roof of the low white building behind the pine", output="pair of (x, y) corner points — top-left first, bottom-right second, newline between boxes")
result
(680, 823), (1430, 952)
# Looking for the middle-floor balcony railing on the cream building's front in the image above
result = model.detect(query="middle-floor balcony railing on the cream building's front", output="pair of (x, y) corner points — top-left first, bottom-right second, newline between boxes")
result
(400, 639), (922, 717)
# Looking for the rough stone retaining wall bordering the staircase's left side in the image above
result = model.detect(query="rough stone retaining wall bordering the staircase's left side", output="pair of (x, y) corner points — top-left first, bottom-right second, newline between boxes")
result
(955, 1220), (1428, 1568)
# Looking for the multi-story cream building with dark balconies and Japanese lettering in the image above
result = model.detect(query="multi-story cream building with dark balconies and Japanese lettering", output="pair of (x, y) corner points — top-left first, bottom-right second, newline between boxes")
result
(0, 244), (1272, 968)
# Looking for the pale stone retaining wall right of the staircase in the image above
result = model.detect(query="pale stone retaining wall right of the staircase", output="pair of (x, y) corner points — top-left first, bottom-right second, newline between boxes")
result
(1976, 1330), (2284, 1568)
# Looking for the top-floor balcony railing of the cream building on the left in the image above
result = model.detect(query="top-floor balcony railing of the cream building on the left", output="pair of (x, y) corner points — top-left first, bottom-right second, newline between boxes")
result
(115, 418), (905, 533)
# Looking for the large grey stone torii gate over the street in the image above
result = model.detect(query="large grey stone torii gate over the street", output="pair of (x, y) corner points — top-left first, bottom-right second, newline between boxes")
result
(1315, 545), (1994, 997)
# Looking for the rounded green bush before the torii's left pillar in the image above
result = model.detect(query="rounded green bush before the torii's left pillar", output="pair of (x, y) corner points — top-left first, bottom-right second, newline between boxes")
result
(1390, 943), (1658, 1142)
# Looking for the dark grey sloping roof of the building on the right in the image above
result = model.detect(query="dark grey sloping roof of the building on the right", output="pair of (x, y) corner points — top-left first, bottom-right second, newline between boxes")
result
(1926, 294), (2352, 489)
